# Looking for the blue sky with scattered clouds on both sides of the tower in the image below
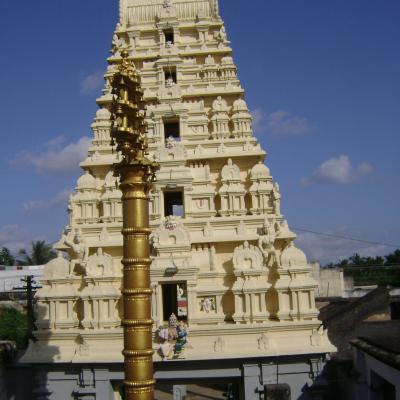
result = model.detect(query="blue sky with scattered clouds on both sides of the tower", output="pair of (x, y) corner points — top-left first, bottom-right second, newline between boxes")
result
(0, 0), (400, 262)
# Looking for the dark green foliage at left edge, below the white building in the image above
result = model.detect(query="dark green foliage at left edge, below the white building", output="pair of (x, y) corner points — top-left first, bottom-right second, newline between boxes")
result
(0, 308), (28, 349)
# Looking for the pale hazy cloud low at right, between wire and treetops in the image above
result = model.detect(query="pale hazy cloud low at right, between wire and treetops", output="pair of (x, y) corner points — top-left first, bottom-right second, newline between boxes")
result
(296, 228), (393, 265)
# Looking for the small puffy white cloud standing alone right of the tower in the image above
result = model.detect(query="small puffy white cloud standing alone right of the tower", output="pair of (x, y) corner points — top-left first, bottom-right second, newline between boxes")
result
(301, 155), (373, 186)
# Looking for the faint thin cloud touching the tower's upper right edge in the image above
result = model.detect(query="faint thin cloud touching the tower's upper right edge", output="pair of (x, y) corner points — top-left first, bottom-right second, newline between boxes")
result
(252, 108), (312, 136)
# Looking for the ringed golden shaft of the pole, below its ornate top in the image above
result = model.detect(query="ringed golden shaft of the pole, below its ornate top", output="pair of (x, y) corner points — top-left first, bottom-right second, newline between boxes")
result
(120, 166), (155, 400)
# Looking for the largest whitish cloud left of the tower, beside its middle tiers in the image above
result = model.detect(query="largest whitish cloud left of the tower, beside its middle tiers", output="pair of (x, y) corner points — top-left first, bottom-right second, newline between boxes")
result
(11, 136), (91, 174)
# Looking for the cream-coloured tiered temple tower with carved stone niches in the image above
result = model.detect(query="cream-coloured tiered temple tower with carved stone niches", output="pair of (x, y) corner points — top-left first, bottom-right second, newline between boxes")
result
(26, 0), (332, 396)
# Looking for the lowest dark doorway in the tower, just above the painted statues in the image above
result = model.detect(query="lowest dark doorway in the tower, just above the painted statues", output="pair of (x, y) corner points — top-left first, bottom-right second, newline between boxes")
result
(162, 282), (188, 322)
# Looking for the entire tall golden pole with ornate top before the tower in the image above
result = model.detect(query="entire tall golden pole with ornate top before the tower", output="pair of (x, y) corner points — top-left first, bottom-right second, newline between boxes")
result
(111, 51), (158, 400)
